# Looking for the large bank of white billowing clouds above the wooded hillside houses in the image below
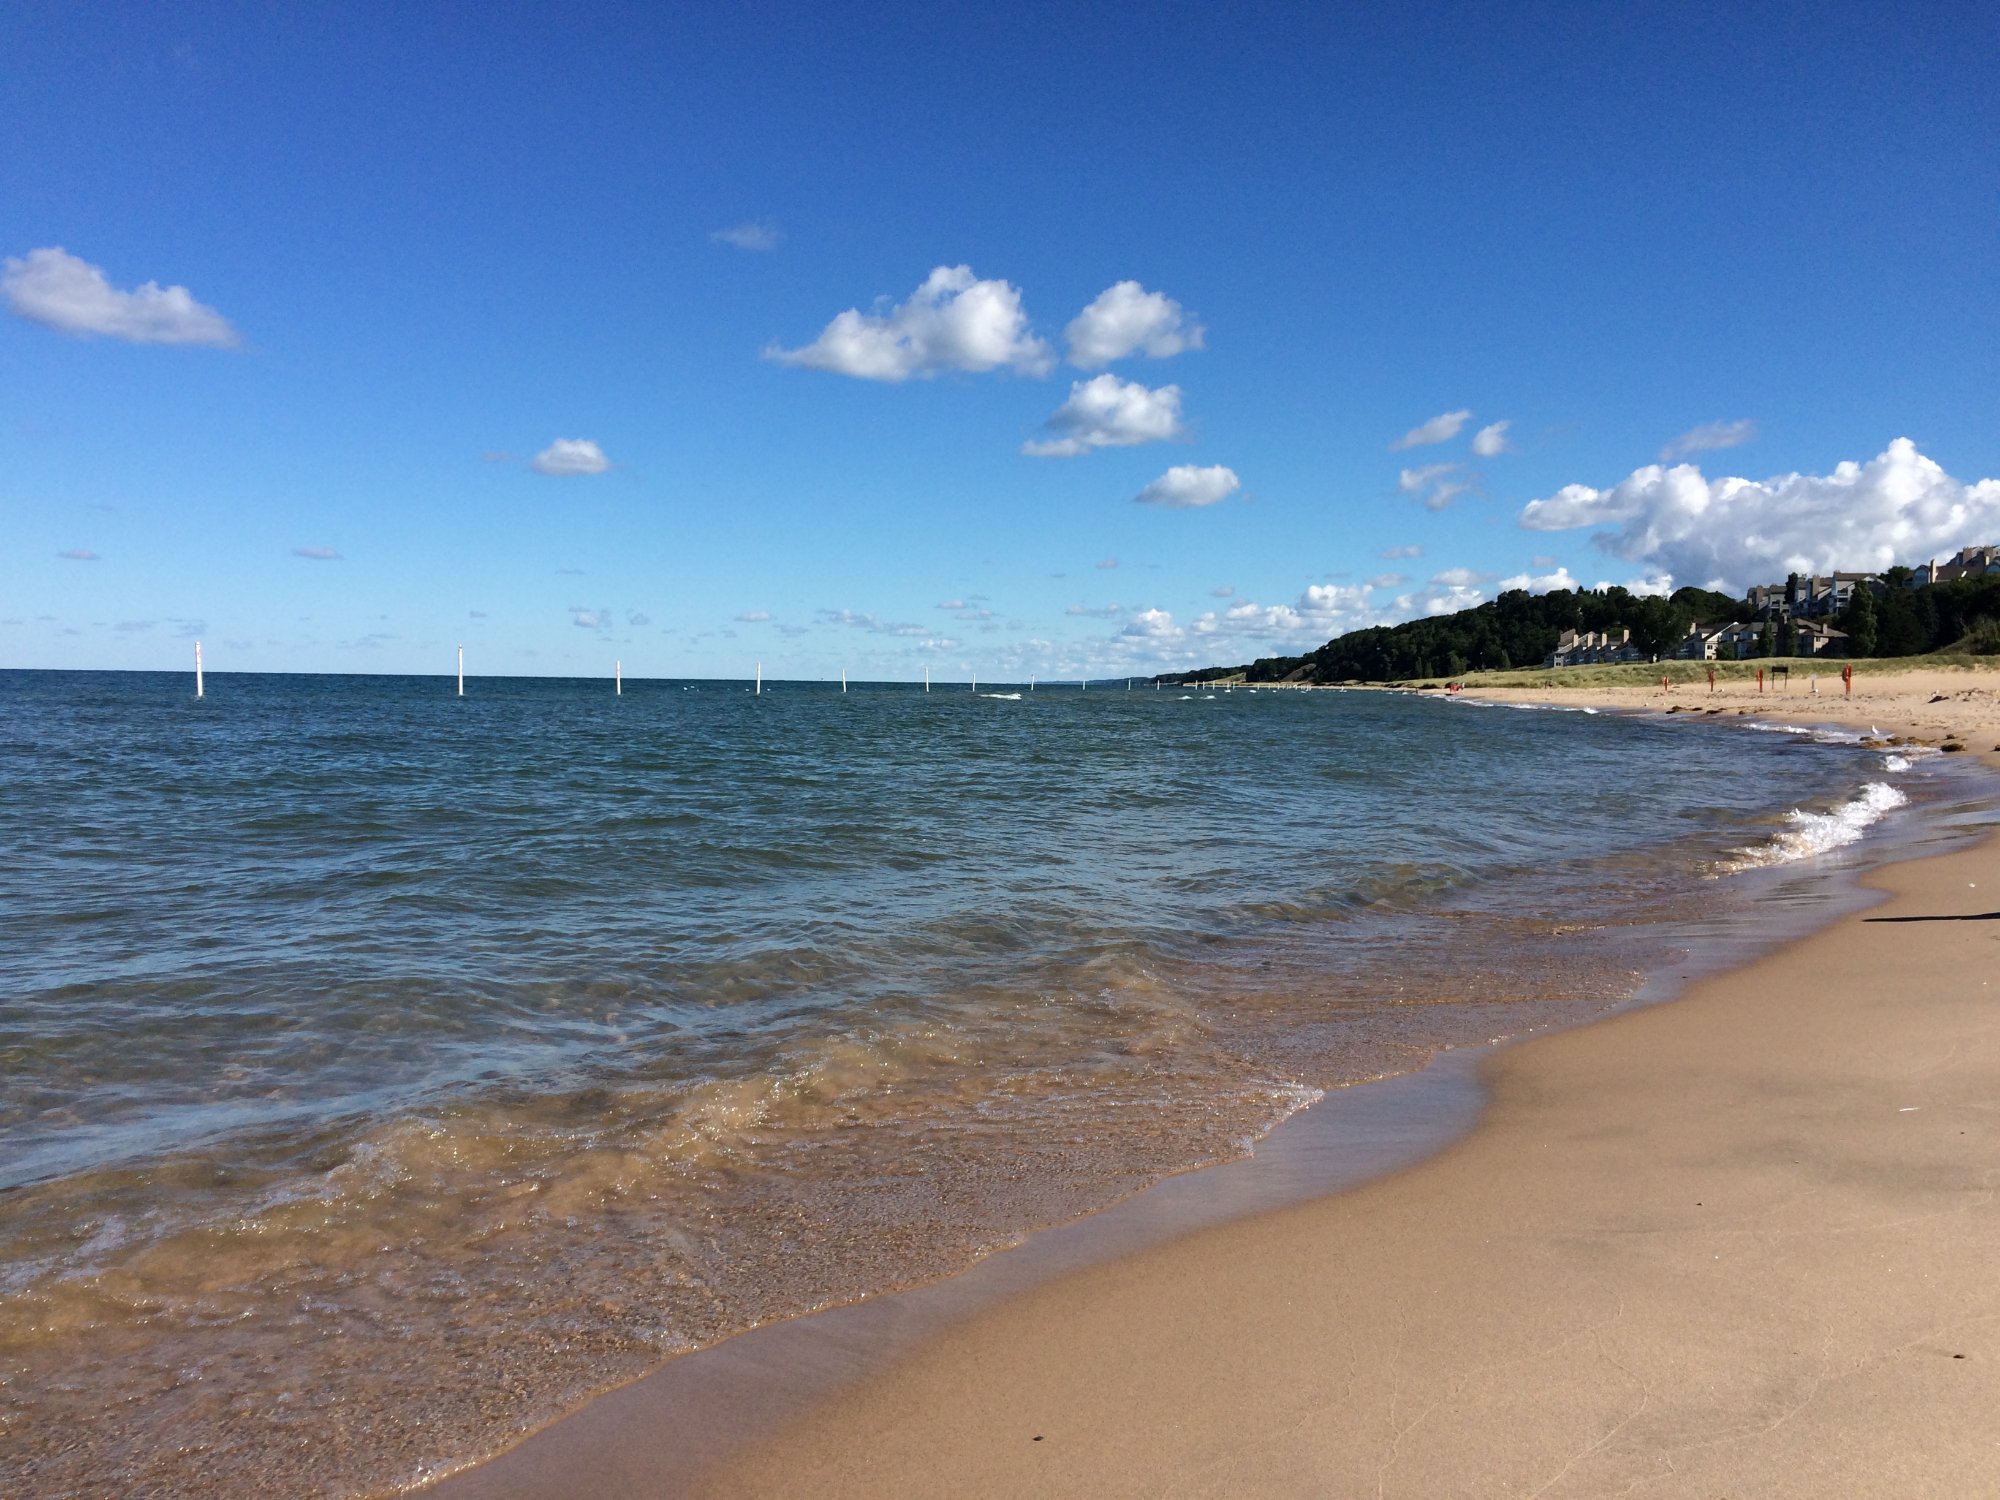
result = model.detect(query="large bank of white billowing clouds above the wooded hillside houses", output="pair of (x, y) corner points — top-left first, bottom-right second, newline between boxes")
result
(1520, 438), (2000, 588)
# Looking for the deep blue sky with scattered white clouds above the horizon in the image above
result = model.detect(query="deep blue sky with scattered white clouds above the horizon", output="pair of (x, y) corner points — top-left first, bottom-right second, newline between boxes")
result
(0, 4), (2000, 678)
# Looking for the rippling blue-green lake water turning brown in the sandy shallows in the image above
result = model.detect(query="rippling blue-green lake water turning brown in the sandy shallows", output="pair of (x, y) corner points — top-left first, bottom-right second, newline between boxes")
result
(0, 672), (1960, 1496)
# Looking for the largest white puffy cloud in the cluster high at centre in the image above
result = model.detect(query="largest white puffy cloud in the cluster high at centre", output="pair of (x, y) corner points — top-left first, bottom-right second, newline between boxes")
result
(764, 266), (1056, 382)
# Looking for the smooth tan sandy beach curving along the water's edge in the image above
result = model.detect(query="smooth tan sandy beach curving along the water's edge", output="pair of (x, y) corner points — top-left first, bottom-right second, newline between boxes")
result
(426, 670), (2000, 1498)
